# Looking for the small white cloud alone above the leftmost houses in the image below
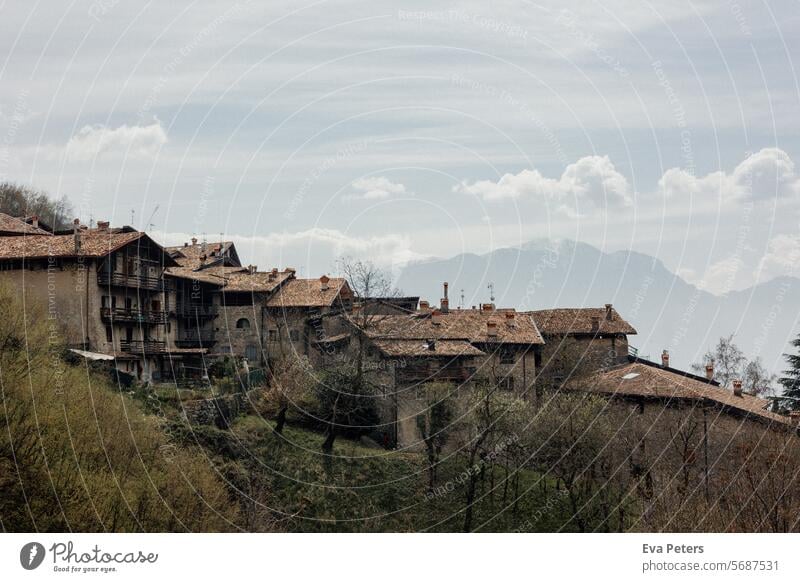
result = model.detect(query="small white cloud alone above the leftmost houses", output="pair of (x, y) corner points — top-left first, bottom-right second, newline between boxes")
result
(67, 121), (167, 160)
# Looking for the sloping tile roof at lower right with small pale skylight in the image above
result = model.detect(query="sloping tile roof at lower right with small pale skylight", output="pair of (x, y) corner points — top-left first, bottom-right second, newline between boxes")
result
(588, 361), (797, 426)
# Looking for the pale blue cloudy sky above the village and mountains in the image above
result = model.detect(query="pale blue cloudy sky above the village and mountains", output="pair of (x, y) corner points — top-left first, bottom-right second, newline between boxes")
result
(0, 0), (800, 294)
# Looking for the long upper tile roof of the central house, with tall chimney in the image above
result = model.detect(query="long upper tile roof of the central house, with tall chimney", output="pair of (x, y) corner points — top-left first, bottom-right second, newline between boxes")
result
(367, 309), (544, 344)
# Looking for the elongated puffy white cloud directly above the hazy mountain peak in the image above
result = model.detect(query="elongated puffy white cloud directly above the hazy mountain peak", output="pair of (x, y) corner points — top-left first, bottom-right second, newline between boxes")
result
(454, 156), (631, 213)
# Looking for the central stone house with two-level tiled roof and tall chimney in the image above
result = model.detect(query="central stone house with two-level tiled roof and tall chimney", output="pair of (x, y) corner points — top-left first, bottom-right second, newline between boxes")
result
(339, 287), (544, 448)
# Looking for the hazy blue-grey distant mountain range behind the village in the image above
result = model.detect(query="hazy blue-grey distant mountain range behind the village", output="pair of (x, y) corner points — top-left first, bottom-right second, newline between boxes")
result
(397, 240), (800, 371)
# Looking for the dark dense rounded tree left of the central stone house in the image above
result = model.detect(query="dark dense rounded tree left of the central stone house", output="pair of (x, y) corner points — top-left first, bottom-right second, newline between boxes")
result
(315, 363), (380, 454)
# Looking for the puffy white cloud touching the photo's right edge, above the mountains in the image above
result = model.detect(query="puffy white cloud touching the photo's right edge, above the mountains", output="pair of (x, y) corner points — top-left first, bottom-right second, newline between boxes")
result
(658, 148), (800, 202)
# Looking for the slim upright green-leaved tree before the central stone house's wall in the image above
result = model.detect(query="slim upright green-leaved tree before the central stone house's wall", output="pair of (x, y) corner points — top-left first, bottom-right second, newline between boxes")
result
(416, 382), (455, 491)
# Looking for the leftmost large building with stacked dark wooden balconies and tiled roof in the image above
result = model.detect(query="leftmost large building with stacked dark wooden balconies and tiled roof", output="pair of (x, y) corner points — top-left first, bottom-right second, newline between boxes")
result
(0, 217), (177, 380)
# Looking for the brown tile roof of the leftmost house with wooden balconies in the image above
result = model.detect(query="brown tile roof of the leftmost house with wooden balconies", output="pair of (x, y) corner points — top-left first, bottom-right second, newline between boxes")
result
(0, 231), (150, 259)
